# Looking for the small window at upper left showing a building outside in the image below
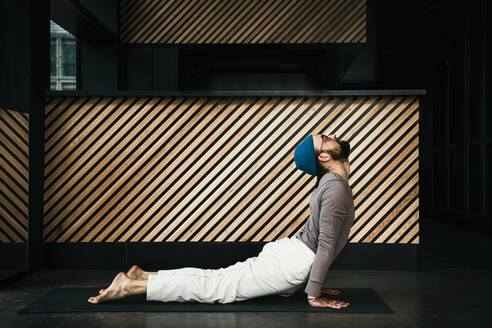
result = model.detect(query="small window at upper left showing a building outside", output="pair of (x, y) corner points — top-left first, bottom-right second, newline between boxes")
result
(50, 21), (77, 90)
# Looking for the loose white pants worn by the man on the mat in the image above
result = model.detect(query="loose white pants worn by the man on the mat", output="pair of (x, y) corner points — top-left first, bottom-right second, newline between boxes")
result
(147, 236), (315, 303)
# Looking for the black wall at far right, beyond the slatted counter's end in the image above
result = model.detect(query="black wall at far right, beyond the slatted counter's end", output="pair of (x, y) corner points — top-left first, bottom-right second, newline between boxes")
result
(420, 1), (492, 234)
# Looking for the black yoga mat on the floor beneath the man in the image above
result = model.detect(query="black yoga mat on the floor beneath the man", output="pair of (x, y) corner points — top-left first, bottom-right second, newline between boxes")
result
(19, 287), (393, 313)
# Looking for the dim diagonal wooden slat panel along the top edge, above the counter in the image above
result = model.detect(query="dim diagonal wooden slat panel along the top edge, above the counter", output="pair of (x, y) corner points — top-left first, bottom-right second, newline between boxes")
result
(119, 0), (367, 44)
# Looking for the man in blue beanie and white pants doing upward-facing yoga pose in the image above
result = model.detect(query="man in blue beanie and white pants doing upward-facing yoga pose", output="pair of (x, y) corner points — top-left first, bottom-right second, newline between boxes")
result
(88, 134), (354, 308)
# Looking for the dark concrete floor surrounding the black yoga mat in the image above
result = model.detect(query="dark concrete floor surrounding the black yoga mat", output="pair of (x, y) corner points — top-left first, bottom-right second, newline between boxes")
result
(0, 221), (492, 328)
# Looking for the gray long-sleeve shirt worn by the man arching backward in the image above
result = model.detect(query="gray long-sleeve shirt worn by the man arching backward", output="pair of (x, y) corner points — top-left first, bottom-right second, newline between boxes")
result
(297, 172), (355, 297)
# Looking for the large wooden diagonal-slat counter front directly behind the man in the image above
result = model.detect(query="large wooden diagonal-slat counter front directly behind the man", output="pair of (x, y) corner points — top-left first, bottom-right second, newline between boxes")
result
(44, 96), (419, 244)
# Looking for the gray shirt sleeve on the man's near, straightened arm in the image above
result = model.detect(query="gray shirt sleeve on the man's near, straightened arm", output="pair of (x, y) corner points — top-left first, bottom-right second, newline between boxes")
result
(305, 180), (350, 297)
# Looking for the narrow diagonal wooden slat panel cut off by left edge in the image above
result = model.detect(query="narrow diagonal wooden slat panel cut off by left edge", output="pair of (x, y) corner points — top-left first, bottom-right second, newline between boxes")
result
(0, 108), (29, 243)
